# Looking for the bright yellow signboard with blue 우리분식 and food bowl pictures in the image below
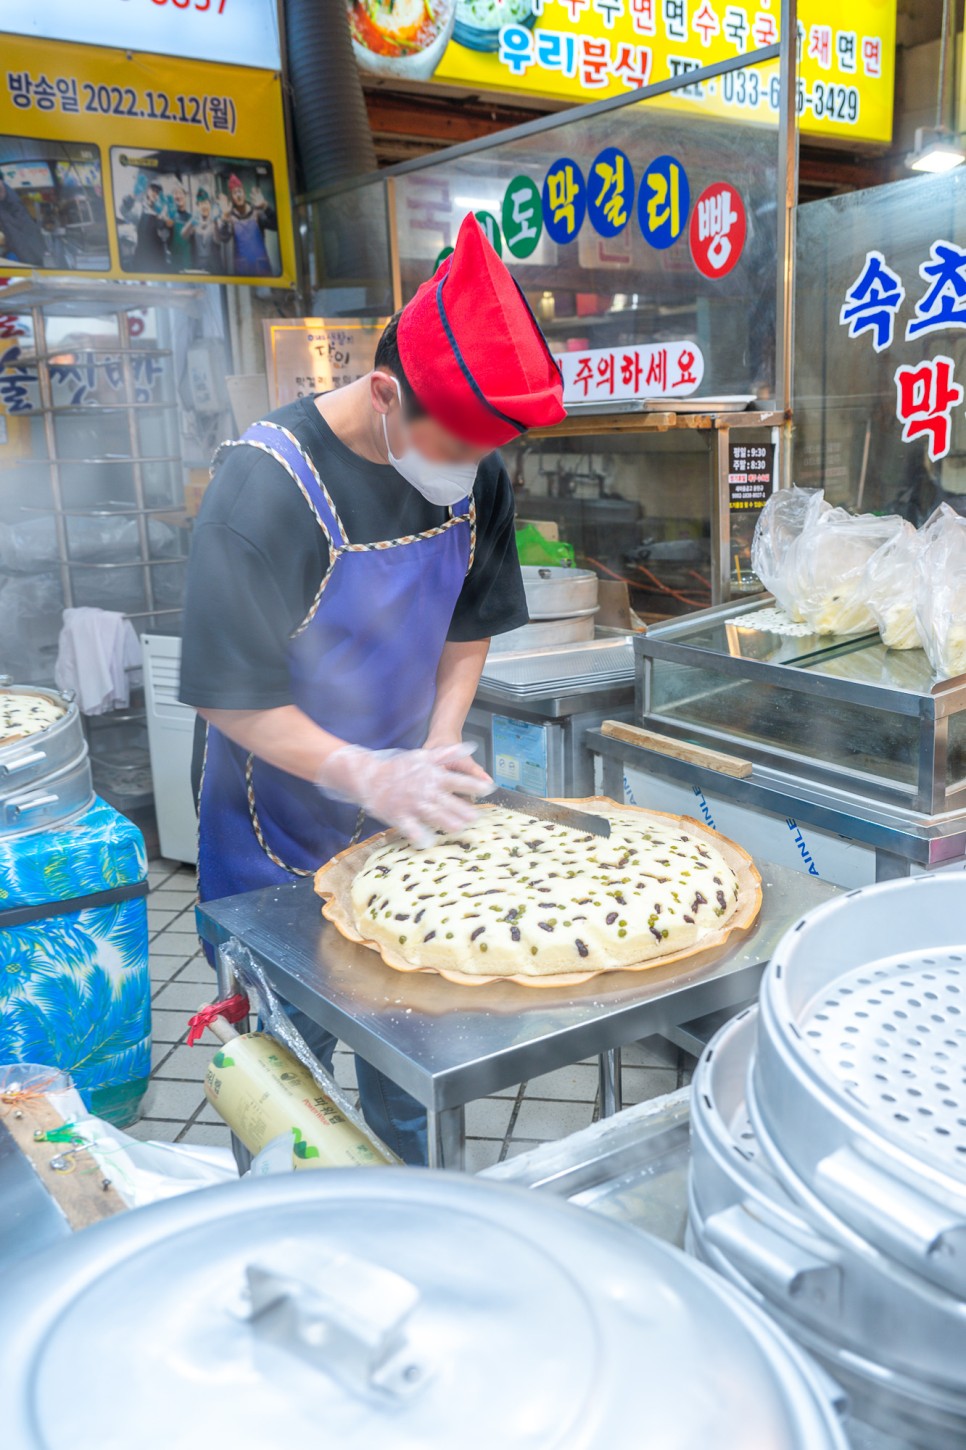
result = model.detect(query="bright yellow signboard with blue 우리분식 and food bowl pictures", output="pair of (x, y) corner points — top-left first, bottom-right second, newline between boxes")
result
(344, 0), (896, 142)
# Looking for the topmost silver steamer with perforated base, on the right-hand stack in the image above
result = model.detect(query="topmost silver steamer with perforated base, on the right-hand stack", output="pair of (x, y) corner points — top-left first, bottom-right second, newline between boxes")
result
(748, 871), (966, 1295)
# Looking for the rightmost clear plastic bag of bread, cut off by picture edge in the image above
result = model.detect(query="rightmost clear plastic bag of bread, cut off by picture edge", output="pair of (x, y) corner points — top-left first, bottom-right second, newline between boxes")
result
(915, 503), (966, 680)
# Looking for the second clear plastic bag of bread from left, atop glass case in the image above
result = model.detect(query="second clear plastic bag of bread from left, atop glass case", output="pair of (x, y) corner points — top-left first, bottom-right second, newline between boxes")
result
(789, 509), (904, 637)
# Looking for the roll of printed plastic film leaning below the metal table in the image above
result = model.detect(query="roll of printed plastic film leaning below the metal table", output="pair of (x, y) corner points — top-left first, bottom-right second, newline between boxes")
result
(205, 1018), (393, 1169)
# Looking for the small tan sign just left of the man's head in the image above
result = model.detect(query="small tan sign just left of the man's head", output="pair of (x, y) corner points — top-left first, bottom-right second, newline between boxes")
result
(264, 318), (389, 407)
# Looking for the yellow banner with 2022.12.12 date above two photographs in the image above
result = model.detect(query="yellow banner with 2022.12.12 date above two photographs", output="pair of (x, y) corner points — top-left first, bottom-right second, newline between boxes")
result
(0, 35), (294, 287)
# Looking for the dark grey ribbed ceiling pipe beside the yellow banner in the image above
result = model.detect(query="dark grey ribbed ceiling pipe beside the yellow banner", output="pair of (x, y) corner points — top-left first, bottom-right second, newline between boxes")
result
(283, 0), (376, 191)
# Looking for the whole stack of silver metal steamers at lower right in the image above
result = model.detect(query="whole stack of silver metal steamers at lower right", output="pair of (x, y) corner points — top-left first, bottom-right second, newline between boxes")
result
(689, 873), (966, 1450)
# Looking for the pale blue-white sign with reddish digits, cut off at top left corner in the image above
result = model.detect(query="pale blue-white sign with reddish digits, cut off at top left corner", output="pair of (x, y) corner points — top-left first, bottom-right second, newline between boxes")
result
(0, 0), (281, 71)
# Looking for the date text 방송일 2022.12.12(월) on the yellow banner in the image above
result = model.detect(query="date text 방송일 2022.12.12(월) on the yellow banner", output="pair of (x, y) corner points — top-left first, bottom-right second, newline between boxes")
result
(7, 71), (236, 133)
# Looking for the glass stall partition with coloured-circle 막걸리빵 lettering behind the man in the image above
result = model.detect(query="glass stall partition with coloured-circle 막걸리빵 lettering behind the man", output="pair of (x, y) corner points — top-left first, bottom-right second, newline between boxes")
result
(299, 46), (795, 622)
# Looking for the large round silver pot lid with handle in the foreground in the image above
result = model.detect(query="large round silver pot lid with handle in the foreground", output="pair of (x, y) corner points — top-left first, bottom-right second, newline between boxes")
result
(0, 1169), (846, 1450)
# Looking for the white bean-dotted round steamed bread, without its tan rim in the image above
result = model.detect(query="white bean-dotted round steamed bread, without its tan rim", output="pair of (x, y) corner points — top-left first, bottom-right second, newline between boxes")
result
(352, 805), (738, 976)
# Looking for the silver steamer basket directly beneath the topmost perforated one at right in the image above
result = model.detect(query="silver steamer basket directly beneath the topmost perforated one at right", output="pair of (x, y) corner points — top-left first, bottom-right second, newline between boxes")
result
(690, 1009), (966, 1392)
